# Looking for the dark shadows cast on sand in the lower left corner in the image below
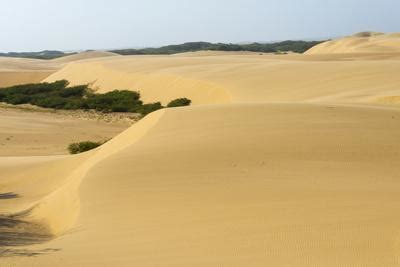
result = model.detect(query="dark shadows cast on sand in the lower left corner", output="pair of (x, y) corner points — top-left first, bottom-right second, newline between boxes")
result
(0, 193), (59, 258)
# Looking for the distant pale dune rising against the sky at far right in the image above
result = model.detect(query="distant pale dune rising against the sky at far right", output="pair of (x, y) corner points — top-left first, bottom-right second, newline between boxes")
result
(306, 32), (400, 54)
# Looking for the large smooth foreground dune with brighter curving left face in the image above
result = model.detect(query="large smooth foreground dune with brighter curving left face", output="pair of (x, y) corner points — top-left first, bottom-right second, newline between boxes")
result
(2, 104), (400, 266)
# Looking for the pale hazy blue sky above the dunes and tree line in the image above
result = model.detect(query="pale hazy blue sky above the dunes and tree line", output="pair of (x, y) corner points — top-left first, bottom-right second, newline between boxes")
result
(0, 0), (400, 52)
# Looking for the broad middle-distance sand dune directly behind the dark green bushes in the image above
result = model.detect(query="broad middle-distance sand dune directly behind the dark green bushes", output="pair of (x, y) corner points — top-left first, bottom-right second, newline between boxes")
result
(46, 51), (400, 105)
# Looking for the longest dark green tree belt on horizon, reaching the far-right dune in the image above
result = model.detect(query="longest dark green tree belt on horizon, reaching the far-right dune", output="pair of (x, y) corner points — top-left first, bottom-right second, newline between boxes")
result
(110, 41), (323, 55)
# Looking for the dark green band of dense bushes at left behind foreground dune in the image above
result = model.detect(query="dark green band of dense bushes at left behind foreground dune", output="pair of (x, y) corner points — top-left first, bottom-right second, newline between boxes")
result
(0, 80), (191, 115)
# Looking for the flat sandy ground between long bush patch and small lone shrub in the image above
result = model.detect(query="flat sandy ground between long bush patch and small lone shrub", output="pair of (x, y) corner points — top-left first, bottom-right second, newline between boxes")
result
(0, 107), (130, 156)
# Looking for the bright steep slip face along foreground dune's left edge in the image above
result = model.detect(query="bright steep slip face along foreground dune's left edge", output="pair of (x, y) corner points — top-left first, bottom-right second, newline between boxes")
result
(0, 111), (163, 235)
